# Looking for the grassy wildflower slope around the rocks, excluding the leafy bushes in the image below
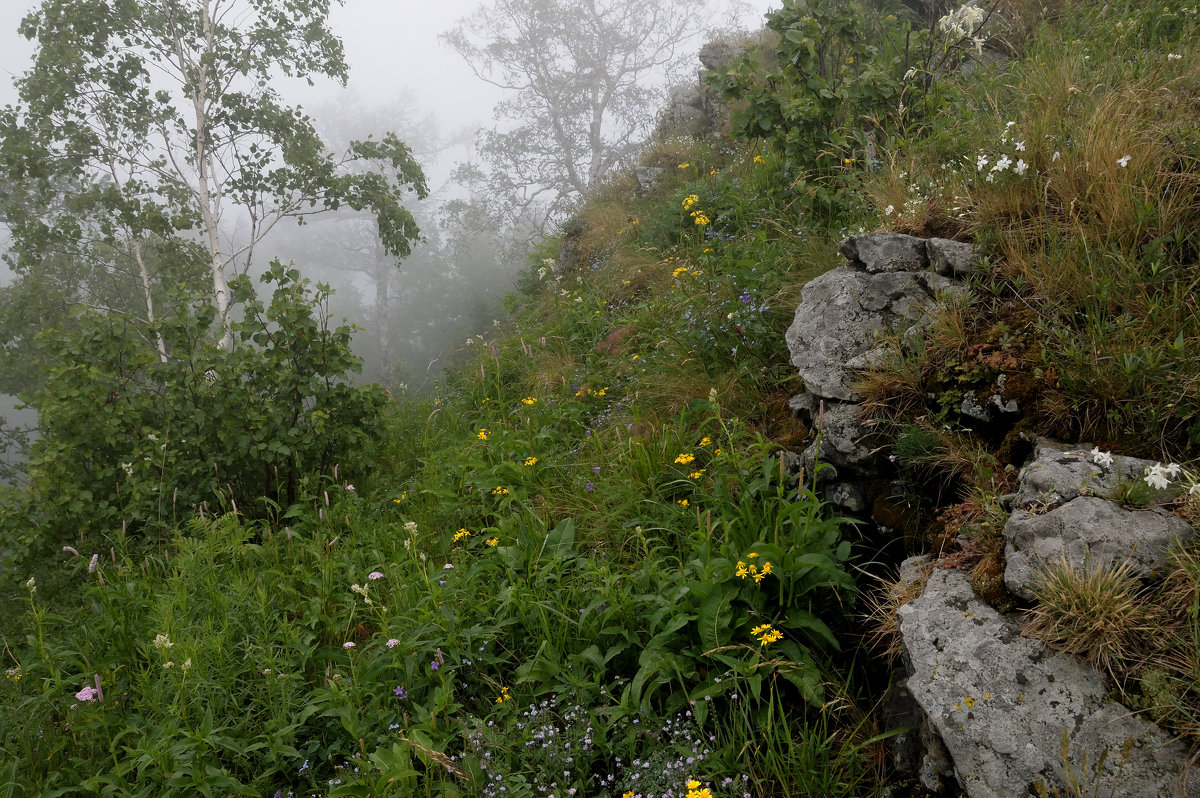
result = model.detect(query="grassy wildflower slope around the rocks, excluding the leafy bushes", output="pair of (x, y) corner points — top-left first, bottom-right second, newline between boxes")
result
(0, 4), (1200, 796)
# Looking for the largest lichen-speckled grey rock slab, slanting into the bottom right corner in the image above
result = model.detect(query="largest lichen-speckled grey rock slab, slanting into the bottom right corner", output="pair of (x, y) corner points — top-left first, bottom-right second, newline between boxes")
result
(899, 569), (1200, 798)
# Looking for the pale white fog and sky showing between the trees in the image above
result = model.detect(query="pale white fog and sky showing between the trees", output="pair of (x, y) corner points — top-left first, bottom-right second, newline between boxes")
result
(0, 0), (778, 463)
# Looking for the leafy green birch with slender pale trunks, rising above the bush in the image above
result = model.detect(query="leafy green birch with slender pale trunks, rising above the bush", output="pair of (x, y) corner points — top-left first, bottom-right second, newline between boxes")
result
(0, 0), (426, 352)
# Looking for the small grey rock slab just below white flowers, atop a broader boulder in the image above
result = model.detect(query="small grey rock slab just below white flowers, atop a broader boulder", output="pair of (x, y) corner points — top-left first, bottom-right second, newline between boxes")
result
(1016, 440), (1153, 508)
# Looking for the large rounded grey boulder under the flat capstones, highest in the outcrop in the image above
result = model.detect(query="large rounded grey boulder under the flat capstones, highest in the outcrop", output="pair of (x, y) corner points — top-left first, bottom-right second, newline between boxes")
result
(787, 266), (964, 402)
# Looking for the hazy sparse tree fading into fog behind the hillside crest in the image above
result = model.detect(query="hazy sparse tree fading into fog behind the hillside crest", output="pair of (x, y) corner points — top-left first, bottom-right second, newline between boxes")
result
(443, 0), (700, 229)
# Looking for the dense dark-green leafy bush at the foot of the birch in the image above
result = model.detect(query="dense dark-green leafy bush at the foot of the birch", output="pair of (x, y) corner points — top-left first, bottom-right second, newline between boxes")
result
(5, 263), (384, 562)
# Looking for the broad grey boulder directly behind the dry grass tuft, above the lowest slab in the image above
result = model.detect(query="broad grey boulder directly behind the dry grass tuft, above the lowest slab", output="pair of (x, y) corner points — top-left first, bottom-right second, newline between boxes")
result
(1004, 496), (1195, 599)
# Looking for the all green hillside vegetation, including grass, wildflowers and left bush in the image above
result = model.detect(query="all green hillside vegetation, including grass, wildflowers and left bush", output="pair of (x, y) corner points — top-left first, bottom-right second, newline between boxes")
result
(0, 0), (1200, 798)
